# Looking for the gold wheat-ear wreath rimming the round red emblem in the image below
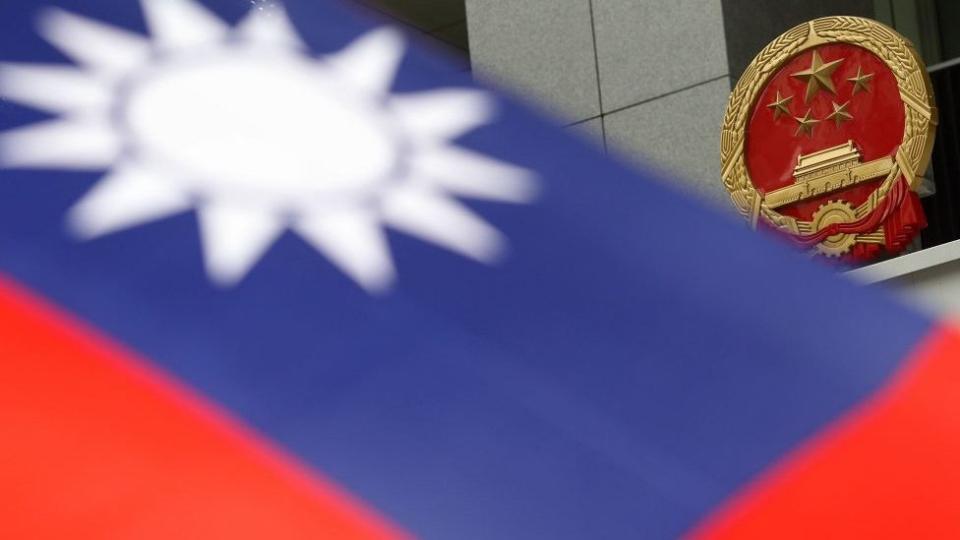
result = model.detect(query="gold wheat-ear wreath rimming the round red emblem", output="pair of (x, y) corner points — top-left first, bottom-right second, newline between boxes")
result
(720, 17), (937, 235)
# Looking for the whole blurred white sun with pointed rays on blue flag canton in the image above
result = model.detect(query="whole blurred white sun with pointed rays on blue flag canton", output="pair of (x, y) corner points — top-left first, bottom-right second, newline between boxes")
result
(0, 0), (536, 292)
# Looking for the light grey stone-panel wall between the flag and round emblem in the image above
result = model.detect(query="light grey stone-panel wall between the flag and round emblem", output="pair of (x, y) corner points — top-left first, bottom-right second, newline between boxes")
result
(466, 0), (730, 208)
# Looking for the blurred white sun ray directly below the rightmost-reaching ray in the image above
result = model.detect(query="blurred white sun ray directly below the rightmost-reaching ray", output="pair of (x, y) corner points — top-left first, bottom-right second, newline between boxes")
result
(383, 189), (506, 263)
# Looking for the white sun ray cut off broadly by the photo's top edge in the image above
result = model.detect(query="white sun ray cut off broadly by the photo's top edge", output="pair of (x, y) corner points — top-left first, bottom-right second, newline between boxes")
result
(141, 0), (230, 51)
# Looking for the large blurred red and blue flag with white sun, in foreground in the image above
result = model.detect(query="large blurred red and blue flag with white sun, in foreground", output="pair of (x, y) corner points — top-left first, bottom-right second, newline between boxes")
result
(0, 0), (960, 539)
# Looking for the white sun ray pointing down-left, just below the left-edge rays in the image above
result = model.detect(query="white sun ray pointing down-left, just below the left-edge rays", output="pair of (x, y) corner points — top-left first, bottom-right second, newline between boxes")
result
(67, 165), (193, 238)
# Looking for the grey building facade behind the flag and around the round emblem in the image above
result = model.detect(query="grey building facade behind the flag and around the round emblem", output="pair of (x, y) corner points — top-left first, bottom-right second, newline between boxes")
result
(348, 0), (960, 314)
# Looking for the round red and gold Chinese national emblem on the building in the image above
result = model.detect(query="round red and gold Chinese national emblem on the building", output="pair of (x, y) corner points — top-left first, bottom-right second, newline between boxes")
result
(721, 17), (937, 263)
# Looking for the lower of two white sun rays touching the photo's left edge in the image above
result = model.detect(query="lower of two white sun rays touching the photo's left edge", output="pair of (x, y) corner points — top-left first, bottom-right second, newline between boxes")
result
(0, 118), (122, 170)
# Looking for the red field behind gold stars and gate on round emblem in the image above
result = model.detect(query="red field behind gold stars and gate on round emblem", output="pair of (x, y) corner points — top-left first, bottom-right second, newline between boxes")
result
(746, 43), (904, 221)
